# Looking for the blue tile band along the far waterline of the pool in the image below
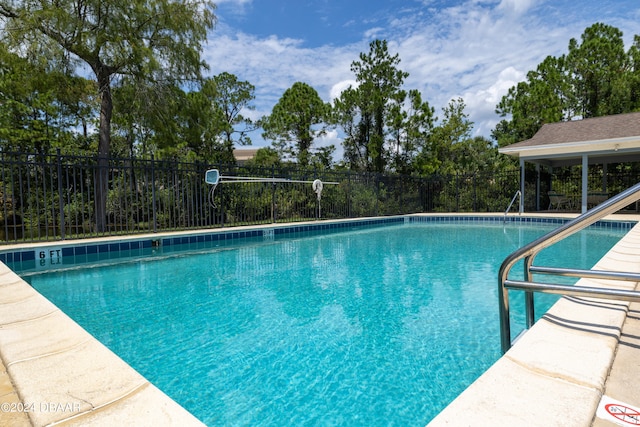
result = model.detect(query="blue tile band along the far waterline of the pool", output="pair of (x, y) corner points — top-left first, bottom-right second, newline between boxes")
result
(0, 215), (636, 263)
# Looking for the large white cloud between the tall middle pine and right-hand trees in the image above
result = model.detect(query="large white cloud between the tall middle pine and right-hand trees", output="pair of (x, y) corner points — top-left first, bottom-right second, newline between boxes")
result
(397, 0), (582, 136)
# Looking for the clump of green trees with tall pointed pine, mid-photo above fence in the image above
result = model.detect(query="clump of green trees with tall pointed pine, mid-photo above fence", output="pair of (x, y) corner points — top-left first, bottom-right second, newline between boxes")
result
(333, 40), (499, 175)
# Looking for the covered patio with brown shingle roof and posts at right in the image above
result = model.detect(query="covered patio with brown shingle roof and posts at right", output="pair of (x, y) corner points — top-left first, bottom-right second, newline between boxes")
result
(498, 112), (640, 213)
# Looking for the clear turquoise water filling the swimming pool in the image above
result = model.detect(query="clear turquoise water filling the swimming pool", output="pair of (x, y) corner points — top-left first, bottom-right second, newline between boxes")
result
(17, 222), (624, 426)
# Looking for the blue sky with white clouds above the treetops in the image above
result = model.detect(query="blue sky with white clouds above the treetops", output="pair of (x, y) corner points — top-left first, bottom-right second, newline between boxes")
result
(203, 0), (640, 154)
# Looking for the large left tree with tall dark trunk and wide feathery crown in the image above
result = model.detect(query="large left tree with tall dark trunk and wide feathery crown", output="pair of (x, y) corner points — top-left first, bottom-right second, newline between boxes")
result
(0, 0), (215, 231)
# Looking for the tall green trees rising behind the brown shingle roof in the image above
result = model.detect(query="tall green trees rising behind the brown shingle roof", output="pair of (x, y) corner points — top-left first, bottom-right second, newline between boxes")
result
(493, 23), (640, 146)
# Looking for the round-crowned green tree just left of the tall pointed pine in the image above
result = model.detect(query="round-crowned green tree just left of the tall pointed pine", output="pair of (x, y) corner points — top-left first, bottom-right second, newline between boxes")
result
(260, 82), (330, 167)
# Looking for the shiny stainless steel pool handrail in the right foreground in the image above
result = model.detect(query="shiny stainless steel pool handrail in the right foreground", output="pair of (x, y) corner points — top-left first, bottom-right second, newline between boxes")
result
(498, 184), (640, 353)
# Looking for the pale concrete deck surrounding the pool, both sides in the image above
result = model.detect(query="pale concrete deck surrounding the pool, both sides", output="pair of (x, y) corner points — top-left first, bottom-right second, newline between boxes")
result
(0, 214), (640, 427)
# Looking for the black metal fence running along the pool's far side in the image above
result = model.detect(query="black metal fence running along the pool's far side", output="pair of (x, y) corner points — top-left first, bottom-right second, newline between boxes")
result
(0, 153), (519, 244)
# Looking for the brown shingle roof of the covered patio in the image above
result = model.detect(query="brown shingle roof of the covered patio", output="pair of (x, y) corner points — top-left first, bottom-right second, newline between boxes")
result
(505, 112), (640, 148)
